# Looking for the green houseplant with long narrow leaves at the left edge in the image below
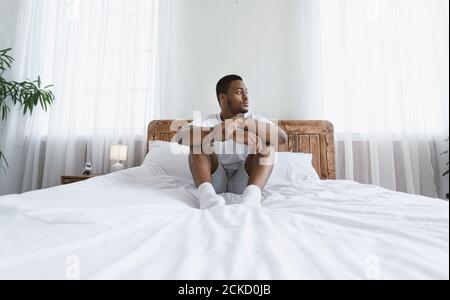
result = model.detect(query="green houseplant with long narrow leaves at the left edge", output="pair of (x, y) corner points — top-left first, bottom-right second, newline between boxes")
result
(0, 49), (55, 171)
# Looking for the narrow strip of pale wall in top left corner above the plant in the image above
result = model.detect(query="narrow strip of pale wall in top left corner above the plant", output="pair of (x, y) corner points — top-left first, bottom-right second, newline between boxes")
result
(0, 0), (19, 49)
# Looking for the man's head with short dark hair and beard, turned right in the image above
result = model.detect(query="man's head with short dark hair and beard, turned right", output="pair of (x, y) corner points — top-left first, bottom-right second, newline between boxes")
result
(216, 75), (250, 115)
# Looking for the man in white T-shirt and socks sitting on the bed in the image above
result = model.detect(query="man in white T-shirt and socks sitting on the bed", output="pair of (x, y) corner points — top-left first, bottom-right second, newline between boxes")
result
(176, 75), (288, 209)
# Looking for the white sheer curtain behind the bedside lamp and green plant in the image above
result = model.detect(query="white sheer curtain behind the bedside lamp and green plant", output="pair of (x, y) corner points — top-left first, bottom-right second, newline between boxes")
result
(0, 0), (159, 194)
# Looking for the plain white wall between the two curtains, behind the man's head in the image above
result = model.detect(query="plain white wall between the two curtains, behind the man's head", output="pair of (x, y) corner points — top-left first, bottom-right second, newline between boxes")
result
(161, 0), (301, 119)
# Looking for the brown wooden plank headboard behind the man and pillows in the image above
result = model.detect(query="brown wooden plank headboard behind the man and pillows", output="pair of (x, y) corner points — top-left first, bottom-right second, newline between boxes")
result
(147, 120), (336, 179)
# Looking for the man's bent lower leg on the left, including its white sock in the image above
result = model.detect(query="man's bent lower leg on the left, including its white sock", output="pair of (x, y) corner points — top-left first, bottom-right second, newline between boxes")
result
(189, 151), (225, 209)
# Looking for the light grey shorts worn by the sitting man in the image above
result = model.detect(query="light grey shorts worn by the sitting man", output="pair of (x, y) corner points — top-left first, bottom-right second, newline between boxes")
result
(212, 161), (249, 195)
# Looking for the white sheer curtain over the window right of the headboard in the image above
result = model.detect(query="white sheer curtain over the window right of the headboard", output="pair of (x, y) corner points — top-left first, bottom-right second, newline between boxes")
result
(299, 0), (449, 197)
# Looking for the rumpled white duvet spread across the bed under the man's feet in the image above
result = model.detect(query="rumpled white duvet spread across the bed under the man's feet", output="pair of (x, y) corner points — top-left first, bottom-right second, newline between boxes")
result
(0, 167), (449, 280)
